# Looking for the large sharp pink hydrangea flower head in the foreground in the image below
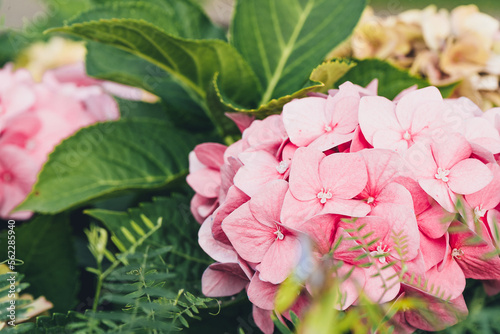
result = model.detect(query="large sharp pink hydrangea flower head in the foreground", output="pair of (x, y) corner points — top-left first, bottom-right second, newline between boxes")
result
(187, 81), (500, 333)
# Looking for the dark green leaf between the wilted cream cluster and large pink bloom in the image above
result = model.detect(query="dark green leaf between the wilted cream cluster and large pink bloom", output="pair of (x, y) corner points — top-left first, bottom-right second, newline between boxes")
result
(337, 59), (456, 100)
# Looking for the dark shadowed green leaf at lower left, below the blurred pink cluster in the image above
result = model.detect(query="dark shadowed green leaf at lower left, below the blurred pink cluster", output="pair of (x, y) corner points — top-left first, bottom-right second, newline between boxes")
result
(0, 214), (79, 312)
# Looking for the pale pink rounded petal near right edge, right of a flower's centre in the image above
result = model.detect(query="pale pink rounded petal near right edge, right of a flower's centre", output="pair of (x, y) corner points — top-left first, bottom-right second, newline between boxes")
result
(448, 159), (493, 195)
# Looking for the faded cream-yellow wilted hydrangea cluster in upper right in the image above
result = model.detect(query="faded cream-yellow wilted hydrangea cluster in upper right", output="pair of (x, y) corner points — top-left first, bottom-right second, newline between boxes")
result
(333, 5), (500, 110)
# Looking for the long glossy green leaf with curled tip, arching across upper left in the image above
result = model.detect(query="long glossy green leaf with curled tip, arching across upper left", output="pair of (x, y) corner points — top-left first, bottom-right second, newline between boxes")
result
(50, 19), (260, 105)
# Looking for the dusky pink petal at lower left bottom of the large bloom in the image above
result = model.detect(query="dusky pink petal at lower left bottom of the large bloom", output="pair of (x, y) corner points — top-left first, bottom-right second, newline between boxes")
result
(201, 263), (249, 297)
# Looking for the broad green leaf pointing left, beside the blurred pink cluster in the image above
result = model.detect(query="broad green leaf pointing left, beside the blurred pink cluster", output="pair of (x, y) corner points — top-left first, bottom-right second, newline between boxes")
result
(18, 118), (196, 213)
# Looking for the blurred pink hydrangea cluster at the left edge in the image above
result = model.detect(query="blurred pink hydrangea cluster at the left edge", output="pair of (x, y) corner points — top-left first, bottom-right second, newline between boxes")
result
(0, 63), (140, 219)
